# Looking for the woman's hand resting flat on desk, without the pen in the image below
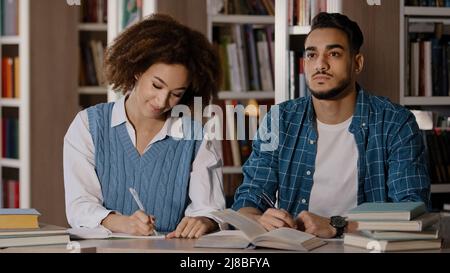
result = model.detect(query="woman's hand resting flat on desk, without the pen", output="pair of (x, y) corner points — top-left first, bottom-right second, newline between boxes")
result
(166, 216), (218, 239)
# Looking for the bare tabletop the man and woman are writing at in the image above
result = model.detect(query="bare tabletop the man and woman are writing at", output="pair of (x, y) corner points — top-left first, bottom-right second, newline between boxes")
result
(0, 239), (450, 253)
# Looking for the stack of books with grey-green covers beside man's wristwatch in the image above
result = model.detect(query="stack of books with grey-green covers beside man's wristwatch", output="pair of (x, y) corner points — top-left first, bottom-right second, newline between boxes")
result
(344, 202), (441, 252)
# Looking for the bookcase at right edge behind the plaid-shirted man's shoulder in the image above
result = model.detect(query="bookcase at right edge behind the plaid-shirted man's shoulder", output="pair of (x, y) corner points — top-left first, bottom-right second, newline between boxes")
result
(399, 0), (450, 210)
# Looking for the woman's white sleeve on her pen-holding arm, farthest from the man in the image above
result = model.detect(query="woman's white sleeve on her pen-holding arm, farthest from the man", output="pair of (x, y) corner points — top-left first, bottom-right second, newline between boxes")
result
(63, 110), (116, 228)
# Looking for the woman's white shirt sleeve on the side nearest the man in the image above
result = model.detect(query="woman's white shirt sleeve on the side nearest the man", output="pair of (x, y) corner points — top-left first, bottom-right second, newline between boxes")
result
(185, 139), (226, 229)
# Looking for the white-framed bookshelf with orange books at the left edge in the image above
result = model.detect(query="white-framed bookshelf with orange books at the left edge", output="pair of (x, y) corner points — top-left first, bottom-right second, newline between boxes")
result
(0, 0), (30, 208)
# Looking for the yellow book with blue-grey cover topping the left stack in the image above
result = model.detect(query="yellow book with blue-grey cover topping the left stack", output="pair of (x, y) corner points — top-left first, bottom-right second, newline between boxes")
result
(0, 209), (41, 229)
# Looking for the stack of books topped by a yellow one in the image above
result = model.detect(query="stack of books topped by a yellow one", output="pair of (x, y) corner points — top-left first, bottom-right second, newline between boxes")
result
(0, 209), (70, 248)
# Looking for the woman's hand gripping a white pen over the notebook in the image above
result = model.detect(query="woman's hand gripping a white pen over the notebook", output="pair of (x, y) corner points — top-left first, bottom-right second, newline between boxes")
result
(102, 210), (155, 236)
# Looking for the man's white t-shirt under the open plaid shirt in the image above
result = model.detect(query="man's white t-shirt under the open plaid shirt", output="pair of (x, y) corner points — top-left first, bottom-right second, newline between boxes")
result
(309, 118), (358, 217)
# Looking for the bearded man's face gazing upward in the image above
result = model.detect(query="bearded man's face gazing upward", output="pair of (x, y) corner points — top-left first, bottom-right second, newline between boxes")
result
(304, 28), (359, 100)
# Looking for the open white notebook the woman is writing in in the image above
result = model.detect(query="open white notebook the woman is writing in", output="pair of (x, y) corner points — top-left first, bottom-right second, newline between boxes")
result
(67, 226), (165, 240)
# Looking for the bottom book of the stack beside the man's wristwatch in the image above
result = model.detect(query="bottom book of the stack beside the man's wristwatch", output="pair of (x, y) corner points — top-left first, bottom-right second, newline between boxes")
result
(344, 233), (441, 252)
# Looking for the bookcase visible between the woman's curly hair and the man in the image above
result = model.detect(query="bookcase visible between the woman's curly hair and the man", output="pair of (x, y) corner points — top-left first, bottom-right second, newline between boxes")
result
(207, 0), (279, 207)
